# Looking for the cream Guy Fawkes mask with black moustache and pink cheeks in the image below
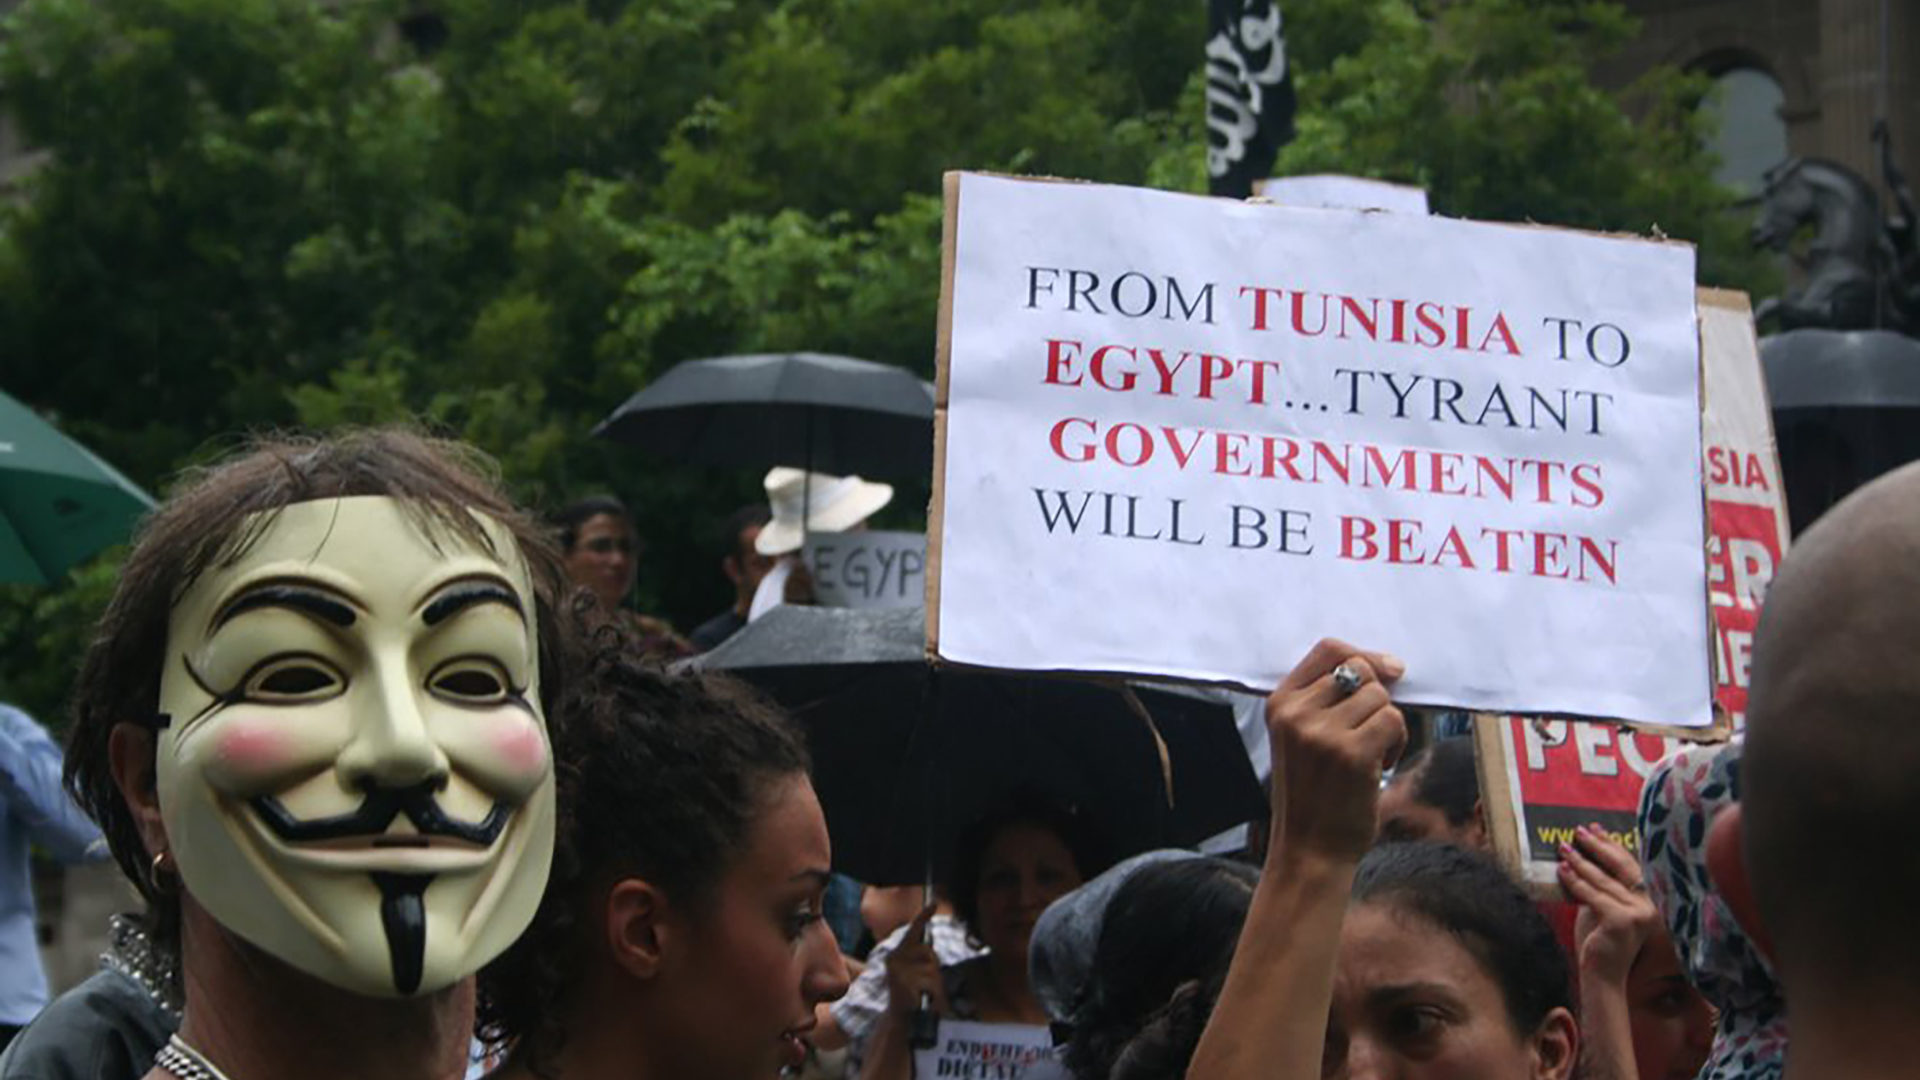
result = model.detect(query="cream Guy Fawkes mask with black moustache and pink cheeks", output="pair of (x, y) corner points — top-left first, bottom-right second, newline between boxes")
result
(156, 496), (555, 995)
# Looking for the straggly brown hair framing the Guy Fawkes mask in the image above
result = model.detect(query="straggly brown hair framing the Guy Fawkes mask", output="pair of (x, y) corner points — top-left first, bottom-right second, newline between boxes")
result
(65, 427), (568, 955)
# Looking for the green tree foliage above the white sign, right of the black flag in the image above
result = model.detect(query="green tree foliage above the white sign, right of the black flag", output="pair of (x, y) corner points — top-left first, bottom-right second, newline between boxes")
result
(1279, 0), (1768, 288)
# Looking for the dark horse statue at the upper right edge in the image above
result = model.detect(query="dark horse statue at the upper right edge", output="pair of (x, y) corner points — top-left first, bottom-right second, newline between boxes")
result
(1751, 141), (1920, 332)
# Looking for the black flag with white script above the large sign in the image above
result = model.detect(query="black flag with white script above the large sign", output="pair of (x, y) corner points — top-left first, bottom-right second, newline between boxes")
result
(1206, 0), (1294, 198)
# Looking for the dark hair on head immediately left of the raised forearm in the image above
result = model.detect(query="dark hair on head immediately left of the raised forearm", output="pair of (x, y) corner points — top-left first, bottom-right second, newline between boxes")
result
(1066, 857), (1258, 1080)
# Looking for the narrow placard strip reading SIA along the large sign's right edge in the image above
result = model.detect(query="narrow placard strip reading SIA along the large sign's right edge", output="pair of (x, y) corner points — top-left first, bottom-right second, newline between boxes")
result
(1699, 288), (1788, 730)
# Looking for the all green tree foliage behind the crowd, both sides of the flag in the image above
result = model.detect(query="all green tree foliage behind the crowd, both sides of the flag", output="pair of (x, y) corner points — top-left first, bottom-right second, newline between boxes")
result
(0, 0), (1755, 715)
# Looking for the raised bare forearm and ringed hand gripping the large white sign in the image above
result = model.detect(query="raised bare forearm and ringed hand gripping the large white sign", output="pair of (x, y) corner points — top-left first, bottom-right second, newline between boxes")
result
(1187, 638), (1407, 1080)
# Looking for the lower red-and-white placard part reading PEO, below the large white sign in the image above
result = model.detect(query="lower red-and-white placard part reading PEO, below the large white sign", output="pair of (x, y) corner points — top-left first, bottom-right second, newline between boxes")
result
(1475, 715), (1680, 892)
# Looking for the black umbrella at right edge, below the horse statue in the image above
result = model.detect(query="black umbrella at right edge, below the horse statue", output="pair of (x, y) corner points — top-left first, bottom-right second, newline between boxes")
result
(1761, 329), (1920, 532)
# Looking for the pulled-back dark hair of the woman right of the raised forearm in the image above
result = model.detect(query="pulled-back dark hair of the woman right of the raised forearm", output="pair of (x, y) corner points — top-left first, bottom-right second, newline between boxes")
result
(1354, 844), (1572, 1034)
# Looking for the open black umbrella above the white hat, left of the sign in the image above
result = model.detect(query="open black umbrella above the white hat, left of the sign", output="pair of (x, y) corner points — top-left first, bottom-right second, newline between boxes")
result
(593, 352), (933, 477)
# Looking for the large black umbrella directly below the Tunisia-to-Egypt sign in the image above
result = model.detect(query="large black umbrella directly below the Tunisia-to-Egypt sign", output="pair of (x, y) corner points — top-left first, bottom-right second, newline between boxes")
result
(687, 605), (1265, 884)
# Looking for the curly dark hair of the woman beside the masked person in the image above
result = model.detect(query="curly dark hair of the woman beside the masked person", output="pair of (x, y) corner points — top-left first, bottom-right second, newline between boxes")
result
(478, 623), (808, 1072)
